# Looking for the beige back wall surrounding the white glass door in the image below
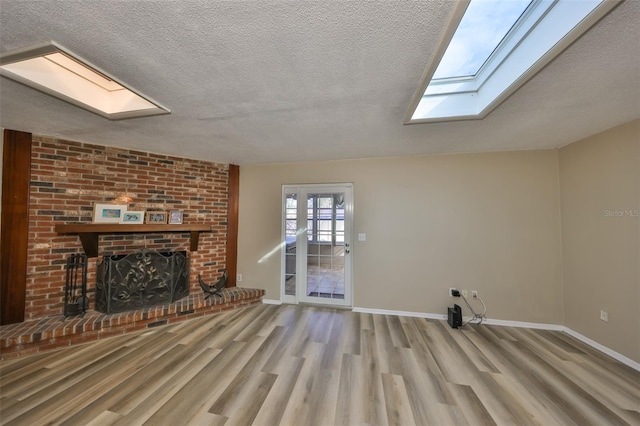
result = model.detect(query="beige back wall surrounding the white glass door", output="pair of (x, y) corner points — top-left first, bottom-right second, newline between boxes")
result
(238, 150), (563, 324)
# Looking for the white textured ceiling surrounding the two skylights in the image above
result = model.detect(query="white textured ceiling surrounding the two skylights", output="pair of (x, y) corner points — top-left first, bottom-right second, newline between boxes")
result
(0, 0), (640, 165)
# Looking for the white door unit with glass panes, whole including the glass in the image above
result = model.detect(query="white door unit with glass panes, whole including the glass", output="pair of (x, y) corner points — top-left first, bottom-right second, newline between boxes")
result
(282, 184), (353, 306)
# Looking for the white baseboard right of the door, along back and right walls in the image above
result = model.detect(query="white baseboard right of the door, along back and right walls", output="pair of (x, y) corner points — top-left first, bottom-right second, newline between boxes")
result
(353, 307), (640, 371)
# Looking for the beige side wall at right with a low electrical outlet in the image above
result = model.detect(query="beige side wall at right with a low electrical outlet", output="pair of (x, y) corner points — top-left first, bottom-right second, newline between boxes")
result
(560, 120), (640, 362)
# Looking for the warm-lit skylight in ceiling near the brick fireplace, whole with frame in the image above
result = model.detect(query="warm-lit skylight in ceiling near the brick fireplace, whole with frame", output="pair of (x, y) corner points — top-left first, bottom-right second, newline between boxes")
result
(0, 42), (171, 120)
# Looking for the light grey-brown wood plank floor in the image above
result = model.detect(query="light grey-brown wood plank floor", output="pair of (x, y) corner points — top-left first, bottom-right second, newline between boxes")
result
(0, 305), (640, 425)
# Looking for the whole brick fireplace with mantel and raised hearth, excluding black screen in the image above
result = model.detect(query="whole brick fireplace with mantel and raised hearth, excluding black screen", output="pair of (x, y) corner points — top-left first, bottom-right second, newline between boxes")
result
(0, 134), (264, 360)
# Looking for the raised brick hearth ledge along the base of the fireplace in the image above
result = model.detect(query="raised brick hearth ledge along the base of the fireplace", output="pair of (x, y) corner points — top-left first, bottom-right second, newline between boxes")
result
(0, 287), (265, 360)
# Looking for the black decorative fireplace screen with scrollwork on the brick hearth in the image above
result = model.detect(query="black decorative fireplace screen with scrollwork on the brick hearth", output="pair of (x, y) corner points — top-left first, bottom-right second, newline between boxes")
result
(96, 249), (189, 314)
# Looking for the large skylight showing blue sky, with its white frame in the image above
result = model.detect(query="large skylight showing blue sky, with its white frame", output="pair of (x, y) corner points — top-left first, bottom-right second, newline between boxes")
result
(404, 0), (621, 124)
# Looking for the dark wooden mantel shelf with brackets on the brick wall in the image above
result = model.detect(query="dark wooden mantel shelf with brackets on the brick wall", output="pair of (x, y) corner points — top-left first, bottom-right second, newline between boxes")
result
(55, 223), (211, 257)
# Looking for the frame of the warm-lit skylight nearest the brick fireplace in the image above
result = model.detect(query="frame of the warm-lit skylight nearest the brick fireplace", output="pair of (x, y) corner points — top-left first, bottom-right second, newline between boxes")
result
(0, 41), (171, 120)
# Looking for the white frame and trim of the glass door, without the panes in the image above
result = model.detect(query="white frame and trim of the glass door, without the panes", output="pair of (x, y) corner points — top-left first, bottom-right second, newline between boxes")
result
(280, 182), (354, 307)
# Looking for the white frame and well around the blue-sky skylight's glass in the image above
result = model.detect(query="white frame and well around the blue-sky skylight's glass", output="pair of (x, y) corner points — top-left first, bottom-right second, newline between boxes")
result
(403, 0), (622, 124)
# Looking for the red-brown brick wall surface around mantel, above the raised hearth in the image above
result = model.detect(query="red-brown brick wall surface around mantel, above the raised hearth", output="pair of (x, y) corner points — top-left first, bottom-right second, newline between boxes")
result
(25, 136), (229, 320)
